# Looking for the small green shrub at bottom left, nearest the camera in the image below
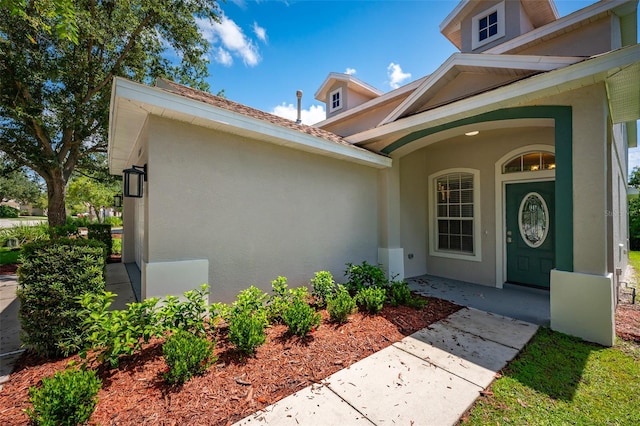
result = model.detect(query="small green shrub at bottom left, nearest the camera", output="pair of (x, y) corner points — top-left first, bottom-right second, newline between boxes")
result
(27, 370), (102, 426)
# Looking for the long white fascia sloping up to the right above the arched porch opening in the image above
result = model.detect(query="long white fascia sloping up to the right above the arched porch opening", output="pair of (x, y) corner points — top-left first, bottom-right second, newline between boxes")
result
(345, 44), (640, 144)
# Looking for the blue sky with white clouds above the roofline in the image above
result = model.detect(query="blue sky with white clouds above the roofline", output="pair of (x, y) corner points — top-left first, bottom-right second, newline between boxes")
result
(195, 0), (640, 169)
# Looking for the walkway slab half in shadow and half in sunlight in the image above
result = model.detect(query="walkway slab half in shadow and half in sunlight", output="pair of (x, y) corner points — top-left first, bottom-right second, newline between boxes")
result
(394, 324), (518, 388)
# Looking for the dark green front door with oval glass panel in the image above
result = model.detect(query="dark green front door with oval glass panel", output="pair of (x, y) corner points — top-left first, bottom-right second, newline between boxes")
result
(505, 181), (555, 288)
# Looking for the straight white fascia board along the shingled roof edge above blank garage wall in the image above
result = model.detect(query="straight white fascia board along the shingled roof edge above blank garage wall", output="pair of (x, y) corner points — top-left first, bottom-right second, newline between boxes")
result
(116, 79), (391, 168)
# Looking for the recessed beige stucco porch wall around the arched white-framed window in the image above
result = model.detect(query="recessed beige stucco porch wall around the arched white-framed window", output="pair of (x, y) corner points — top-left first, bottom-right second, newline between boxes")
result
(400, 127), (554, 286)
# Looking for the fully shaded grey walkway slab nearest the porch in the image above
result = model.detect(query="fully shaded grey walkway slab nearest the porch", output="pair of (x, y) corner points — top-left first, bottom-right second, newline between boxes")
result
(441, 308), (538, 350)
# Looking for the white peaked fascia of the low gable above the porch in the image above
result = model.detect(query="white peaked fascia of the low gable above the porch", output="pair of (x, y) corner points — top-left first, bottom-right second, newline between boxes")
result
(380, 53), (584, 125)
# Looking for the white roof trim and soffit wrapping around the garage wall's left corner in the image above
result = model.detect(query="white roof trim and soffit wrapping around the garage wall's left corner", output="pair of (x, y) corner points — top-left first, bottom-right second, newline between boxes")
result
(108, 78), (391, 174)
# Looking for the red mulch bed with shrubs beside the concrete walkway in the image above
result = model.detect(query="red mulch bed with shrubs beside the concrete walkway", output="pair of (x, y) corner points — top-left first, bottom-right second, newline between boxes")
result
(0, 298), (460, 425)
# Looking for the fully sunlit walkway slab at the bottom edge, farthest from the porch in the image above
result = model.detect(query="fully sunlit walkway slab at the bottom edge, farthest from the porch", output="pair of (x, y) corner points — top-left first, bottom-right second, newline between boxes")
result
(235, 385), (372, 426)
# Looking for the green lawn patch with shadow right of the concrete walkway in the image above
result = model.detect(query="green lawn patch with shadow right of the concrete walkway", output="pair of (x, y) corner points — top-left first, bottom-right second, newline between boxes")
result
(464, 326), (640, 425)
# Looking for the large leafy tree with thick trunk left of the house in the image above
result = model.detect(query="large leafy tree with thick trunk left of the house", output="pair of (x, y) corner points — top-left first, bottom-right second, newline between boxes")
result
(0, 0), (219, 226)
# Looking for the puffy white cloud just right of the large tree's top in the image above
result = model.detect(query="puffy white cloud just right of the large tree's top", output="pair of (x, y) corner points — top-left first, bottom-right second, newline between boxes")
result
(198, 16), (260, 67)
